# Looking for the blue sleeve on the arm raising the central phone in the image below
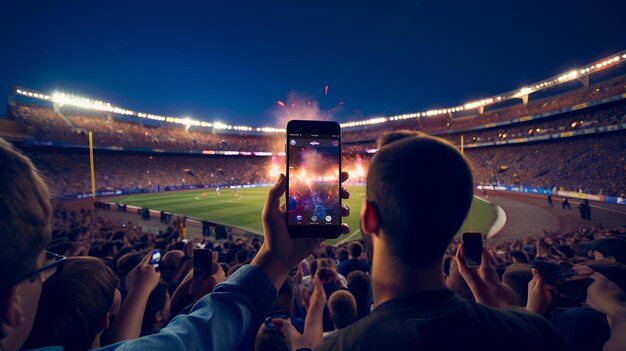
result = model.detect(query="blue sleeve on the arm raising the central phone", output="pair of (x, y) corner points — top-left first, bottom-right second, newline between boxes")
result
(98, 265), (276, 351)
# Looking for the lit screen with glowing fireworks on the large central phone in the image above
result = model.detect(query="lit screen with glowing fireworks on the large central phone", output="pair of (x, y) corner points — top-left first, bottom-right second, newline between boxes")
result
(287, 133), (341, 226)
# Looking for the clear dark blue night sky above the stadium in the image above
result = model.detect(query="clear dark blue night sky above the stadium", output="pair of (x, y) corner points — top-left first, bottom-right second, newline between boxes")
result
(0, 0), (626, 126)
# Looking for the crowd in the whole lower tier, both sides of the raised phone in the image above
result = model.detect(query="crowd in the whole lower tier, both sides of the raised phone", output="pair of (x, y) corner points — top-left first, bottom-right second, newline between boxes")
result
(22, 126), (626, 196)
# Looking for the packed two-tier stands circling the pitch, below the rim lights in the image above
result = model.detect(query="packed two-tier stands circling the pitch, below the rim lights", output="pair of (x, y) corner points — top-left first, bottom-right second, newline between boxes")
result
(8, 76), (626, 197)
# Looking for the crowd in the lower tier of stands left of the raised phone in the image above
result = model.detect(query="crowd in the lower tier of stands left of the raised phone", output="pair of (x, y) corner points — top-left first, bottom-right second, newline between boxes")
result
(28, 150), (270, 195)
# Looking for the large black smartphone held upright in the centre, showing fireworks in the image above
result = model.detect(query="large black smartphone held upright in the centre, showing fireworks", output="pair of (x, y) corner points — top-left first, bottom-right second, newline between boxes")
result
(285, 120), (341, 238)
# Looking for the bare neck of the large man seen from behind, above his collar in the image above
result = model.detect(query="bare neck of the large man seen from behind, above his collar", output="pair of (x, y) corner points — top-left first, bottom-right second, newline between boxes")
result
(372, 245), (446, 307)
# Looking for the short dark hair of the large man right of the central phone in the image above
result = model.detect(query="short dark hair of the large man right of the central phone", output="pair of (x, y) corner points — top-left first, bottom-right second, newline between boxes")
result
(366, 131), (473, 265)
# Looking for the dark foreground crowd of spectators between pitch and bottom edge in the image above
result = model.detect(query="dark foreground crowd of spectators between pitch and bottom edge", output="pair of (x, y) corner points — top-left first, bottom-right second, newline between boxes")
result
(15, 187), (626, 350)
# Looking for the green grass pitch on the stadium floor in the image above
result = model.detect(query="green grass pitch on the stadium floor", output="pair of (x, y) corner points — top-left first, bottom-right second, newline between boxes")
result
(109, 186), (496, 243)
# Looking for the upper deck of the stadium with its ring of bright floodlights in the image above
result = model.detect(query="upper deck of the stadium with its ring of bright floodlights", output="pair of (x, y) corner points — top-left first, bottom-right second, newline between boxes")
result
(9, 51), (626, 155)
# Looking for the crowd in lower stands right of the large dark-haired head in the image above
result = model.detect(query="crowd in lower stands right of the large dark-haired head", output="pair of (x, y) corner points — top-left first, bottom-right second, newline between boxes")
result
(465, 132), (626, 196)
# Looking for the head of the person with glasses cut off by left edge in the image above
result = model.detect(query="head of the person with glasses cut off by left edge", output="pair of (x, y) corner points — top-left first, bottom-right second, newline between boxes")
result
(0, 139), (52, 350)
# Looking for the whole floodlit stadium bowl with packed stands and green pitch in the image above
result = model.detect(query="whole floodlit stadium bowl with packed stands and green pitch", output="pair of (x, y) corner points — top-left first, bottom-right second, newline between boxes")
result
(2, 51), (626, 242)
